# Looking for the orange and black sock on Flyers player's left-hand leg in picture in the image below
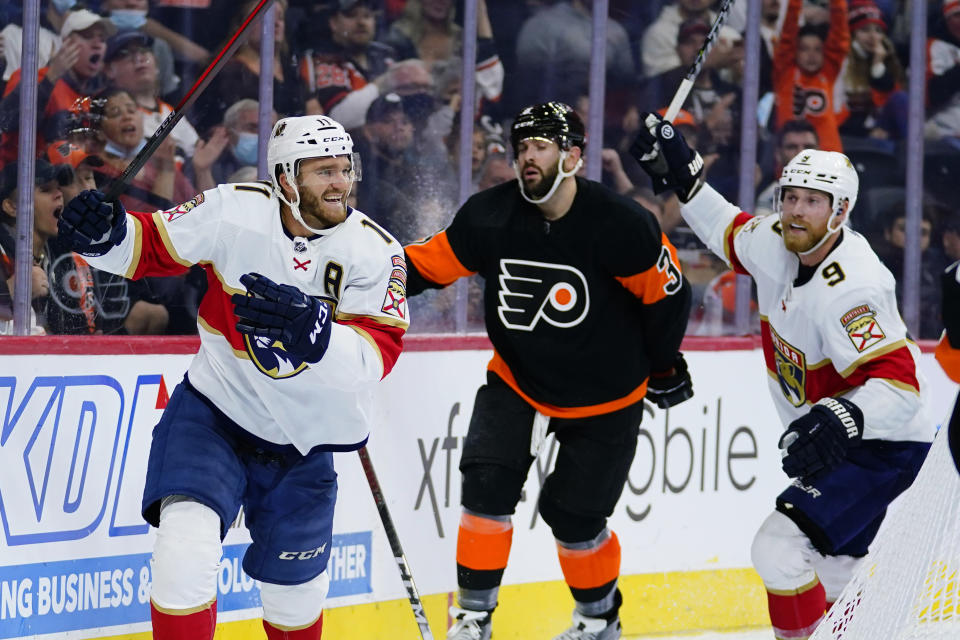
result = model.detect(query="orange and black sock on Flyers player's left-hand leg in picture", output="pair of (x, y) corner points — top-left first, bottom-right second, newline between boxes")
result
(457, 510), (513, 611)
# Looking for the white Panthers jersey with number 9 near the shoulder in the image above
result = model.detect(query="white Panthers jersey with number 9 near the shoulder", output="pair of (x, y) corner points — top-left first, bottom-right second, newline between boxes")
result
(681, 185), (935, 442)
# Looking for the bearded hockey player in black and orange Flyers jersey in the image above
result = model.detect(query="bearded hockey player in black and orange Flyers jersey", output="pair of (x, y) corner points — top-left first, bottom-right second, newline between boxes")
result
(405, 102), (693, 640)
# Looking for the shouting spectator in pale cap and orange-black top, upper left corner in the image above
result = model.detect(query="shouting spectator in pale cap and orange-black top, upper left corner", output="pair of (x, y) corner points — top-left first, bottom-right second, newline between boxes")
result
(0, 9), (116, 163)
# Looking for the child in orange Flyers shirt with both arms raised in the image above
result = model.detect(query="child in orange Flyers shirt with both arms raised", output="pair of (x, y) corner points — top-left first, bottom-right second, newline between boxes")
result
(773, 0), (850, 151)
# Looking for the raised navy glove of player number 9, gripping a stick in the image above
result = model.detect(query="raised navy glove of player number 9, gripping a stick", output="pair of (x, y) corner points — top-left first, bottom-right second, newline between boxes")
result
(630, 113), (703, 202)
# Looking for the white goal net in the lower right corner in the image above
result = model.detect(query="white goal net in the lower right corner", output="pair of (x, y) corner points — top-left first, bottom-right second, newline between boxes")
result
(810, 428), (960, 640)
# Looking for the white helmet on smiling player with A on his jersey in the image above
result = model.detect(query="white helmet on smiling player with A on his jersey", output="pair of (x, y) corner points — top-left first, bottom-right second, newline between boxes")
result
(267, 116), (360, 232)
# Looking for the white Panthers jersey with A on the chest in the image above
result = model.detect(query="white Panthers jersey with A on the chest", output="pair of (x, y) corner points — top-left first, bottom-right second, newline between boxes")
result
(89, 182), (409, 453)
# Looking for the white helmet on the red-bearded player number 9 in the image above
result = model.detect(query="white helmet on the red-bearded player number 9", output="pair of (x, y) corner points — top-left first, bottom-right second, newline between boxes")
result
(773, 149), (860, 255)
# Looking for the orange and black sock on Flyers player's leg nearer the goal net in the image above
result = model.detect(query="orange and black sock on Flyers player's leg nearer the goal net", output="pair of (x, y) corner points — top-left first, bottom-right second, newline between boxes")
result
(557, 529), (622, 620)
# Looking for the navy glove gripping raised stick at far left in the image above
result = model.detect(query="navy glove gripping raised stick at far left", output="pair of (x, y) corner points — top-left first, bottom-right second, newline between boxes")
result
(57, 190), (127, 256)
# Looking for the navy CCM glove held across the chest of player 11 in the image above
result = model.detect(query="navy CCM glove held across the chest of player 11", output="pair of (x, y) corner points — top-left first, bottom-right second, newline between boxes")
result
(230, 273), (332, 363)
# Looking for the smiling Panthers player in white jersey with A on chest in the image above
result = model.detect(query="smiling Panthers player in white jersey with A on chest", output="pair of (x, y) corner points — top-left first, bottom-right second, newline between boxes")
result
(60, 116), (409, 640)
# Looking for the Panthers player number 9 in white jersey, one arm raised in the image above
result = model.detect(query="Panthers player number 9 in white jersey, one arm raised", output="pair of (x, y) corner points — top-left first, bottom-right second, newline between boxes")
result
(631, 114), (934, 640)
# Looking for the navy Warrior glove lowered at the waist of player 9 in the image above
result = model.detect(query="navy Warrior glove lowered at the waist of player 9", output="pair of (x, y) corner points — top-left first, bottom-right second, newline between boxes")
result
(779, 397), (863, 478)
